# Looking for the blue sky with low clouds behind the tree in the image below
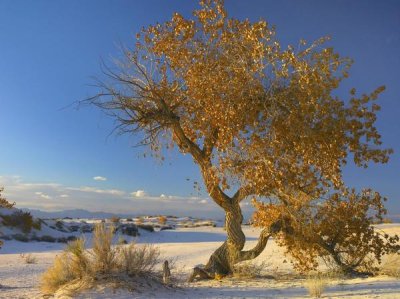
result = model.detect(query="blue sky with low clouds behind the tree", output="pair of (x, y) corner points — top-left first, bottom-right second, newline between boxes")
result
(0, 0), (400, 220)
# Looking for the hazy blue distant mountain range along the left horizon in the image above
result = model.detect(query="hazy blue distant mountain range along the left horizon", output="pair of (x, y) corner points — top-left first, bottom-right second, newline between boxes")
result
(21, 209), (133, 219)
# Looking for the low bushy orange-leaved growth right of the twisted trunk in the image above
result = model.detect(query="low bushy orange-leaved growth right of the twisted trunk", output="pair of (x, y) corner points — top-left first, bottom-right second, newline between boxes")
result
(254, 189), (400, 273)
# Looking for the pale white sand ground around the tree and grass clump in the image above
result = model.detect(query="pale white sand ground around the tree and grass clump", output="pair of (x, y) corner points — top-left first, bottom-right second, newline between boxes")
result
(0, 224), (400, 299)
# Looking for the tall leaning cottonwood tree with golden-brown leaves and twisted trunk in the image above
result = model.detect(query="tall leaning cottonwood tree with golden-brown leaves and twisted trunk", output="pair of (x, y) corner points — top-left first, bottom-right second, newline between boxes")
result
(88, 0), (390, 279)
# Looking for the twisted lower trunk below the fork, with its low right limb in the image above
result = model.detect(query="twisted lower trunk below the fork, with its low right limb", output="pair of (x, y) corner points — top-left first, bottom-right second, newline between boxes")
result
(189, 202), (271, 282)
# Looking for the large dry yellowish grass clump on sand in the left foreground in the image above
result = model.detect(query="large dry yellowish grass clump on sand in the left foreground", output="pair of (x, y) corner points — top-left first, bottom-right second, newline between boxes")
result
(40, 223), (161, 294)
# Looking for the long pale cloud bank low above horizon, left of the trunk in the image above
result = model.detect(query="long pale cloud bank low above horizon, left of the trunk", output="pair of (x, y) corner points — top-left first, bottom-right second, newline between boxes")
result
(0, 176), (223, 218)
